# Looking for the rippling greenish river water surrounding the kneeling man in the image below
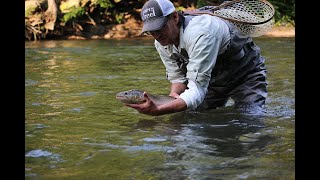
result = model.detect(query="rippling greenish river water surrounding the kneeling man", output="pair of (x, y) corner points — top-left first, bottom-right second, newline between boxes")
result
(25, 37), (295, 179)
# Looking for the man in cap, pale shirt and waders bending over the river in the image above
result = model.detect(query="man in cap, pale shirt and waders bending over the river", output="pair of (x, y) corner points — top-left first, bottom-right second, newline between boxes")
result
(127, 0), (267, 115)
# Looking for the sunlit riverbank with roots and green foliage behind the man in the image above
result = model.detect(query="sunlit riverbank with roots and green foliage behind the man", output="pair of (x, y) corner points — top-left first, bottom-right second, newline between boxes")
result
(25, 0), (295, 41)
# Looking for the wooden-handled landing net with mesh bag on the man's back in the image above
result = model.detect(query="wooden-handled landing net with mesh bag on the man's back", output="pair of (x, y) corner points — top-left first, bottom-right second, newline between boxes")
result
(185, 0), (275, 37)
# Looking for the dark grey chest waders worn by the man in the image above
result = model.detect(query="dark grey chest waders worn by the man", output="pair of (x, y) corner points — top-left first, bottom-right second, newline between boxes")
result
(183, 15), (268, 113)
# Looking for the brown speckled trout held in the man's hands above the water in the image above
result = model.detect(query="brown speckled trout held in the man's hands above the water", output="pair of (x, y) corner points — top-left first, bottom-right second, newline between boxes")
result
(116, 89), (176, 106)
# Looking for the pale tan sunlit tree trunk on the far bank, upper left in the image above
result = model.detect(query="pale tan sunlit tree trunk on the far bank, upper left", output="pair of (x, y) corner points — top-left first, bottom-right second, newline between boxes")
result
(44, 0), (58, 30)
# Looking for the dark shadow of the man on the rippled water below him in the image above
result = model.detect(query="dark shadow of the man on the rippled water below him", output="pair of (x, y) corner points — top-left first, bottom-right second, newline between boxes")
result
(134, 111), (273, 157)
